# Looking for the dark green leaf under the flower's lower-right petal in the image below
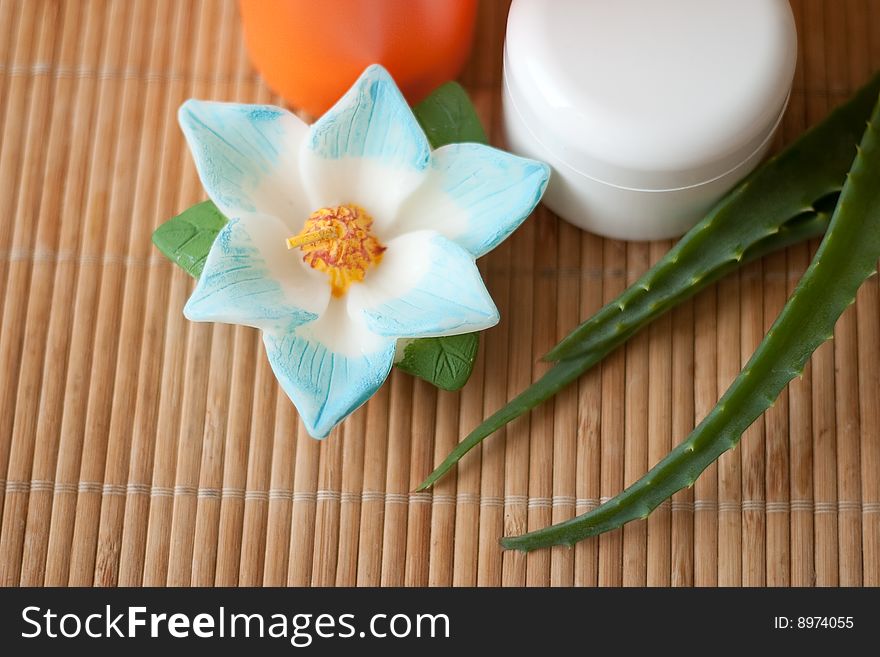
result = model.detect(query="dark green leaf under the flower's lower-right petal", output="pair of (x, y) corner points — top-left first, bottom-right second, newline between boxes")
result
(397, 333), (480, 390)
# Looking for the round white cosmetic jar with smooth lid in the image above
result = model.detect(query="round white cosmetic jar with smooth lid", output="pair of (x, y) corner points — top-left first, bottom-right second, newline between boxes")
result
(503, 0), (797, 240)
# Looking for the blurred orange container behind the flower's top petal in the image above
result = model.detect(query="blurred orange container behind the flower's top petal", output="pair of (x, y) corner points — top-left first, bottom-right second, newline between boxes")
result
(239, 0), (477, 116)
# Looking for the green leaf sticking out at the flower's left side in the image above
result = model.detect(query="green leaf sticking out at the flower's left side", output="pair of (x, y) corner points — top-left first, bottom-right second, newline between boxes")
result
(153, 201), (227, 278)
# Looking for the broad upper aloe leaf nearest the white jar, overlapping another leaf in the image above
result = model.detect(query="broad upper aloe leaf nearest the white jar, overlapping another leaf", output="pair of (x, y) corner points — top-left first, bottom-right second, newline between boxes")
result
(545, 70), (880, 360)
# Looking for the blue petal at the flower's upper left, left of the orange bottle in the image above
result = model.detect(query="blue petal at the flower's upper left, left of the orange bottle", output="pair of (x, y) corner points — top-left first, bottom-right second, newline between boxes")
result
(178, 100), (309, 219)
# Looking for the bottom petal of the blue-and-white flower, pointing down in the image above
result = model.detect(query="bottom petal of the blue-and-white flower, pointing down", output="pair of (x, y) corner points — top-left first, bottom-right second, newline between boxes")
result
(263, 300), (395, 438)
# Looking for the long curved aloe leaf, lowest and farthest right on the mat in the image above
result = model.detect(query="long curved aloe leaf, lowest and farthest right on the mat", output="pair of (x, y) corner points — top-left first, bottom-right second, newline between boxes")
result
(501, 95), (880, 551)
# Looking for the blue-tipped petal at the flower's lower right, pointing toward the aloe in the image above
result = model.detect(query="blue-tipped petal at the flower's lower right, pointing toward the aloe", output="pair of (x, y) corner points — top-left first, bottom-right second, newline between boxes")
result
(349, 231), (498, 338)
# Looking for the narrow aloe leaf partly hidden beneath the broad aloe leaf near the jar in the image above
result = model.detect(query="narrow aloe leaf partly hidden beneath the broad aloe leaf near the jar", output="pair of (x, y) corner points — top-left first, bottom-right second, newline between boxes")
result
(417, 212), (831, 490)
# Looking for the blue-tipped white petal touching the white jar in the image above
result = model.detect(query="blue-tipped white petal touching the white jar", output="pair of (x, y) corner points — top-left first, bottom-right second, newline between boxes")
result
(395, 144), (550, 257)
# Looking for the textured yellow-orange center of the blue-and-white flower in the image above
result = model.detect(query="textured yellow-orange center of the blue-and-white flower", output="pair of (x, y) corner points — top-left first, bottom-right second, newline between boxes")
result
(287, 203), (385, 297)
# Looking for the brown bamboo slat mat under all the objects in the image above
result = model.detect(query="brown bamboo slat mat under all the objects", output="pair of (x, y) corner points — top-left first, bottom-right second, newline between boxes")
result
(0, 0), (880, 586)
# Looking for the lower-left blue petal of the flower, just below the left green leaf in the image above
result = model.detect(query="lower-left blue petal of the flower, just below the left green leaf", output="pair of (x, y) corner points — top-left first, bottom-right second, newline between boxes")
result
(183, 216), (329, 331)
